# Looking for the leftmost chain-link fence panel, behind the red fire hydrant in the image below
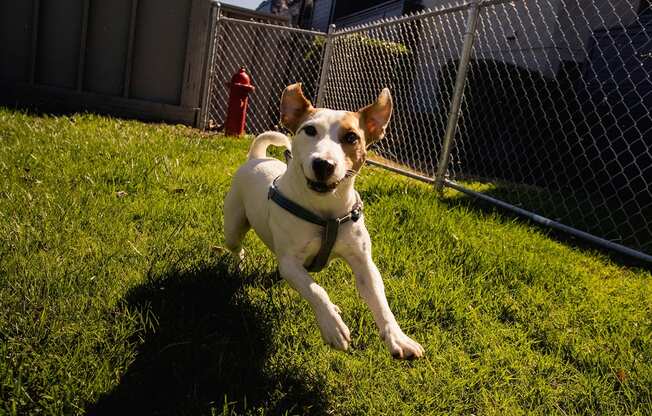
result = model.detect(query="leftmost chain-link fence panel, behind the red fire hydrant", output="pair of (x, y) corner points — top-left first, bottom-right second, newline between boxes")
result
(197, 16), (326, 133)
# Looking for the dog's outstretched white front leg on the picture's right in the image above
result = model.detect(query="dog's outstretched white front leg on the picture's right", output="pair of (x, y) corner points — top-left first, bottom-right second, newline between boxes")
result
(345, 249), (425, 359)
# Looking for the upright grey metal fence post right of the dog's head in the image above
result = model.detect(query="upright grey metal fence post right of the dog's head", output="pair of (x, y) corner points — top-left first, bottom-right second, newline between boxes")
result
(435, 1), (480, 192)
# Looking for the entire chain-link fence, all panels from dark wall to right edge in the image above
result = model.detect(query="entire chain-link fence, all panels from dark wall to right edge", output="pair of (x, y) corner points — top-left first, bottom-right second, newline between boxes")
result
(204, 0), (652, 261)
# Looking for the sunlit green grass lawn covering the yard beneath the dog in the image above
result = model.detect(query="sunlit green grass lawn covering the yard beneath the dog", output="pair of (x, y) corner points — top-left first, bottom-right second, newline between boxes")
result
(0, 109), (652, 415)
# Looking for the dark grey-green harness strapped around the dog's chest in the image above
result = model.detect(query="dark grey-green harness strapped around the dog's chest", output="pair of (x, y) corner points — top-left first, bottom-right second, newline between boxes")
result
(267, 177), (362, 272)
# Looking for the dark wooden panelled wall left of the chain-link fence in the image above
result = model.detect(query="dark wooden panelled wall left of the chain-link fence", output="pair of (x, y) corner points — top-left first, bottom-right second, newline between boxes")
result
(0, 0), (211, 124)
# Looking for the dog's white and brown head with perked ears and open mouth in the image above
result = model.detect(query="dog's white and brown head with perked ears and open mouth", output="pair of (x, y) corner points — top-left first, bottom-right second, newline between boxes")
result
(281, 83), (392, 193)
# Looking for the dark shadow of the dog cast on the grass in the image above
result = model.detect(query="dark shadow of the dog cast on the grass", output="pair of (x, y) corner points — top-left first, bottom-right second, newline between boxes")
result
(87, 260), (327, 415)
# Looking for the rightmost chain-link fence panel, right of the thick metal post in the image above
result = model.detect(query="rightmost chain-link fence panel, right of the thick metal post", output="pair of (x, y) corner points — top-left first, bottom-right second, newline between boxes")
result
(449, 0), (652, 253)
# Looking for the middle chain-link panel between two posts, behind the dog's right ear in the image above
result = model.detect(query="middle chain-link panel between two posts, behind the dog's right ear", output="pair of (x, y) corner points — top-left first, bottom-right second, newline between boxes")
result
(320, 8), (466, 176)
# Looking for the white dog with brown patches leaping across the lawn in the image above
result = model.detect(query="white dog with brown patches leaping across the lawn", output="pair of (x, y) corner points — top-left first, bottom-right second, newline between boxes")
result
(224, 84), (424, 359)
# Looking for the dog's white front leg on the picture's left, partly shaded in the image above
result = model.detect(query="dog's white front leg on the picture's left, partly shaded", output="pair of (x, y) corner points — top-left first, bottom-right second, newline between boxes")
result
(279, 256), (351, 351)
